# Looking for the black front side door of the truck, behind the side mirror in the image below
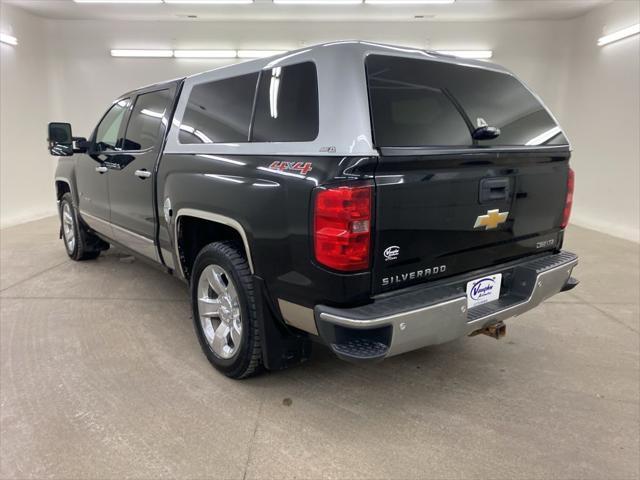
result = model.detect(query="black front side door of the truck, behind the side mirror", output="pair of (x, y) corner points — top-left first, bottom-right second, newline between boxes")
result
(75, 98), (131, 238)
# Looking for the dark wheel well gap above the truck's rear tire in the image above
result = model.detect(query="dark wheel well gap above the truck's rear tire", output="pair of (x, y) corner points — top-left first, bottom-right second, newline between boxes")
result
(176, 216), (247, 280)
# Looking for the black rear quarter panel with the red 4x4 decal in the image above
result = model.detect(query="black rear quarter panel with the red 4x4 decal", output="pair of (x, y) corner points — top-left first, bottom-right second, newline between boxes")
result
(157, 154), (375, 307)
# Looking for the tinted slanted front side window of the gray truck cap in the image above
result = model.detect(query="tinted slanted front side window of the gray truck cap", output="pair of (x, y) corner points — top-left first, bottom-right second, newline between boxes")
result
(178, 73), (258, 143)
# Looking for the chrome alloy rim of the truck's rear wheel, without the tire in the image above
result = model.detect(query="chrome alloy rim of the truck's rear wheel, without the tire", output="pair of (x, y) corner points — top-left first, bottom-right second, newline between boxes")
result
(198, 265), (242, 359)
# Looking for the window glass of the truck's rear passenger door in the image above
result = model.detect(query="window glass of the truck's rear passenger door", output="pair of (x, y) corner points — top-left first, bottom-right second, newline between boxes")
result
(123, 90), (171, 150)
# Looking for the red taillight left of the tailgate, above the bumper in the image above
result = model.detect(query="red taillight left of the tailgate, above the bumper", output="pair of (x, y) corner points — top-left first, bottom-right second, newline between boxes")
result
(313, 187), (372, 272)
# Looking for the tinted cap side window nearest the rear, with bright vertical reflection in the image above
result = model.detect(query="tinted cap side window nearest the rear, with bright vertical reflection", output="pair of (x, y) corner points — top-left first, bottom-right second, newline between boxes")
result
(251, 62), (318, 142)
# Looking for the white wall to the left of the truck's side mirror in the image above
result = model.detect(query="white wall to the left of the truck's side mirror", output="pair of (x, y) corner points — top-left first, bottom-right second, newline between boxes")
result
(0, 3), (55, 226)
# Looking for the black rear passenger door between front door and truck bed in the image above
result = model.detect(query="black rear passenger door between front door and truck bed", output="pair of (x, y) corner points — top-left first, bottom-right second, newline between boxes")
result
(107, 85), (176, 261)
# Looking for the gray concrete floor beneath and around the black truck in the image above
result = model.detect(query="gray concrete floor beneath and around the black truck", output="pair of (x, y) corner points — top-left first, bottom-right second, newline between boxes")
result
(0, 219), (640, 479)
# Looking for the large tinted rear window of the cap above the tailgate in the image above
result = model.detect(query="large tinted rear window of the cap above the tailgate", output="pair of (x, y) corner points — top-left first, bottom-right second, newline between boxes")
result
(365, 55), (567, 147)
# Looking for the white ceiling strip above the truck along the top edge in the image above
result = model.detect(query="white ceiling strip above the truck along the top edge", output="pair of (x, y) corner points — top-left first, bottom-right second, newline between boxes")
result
(0, 0), (612, 22)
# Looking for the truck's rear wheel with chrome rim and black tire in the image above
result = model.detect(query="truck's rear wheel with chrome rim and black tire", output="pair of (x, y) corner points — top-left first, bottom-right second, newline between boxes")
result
(191, 242), (262, 378)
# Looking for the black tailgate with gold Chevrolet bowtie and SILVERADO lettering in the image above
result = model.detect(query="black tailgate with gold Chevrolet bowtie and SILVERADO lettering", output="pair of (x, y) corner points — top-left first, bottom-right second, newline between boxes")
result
(373, 155), (568, 293)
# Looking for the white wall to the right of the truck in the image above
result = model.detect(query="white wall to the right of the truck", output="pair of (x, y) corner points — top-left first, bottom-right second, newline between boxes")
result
(559, 1), (640, 241)
